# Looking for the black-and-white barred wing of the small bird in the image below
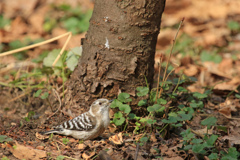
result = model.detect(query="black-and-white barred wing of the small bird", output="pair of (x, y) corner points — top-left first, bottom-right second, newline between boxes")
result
(54, 112), (97, 131)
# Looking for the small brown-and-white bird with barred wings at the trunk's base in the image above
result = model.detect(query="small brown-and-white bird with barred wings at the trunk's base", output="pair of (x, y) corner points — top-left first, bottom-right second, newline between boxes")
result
(41, 98), (112, 140)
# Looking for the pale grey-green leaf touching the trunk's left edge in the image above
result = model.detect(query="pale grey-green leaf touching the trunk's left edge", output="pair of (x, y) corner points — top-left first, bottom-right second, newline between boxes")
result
(66, 46), (82, 71)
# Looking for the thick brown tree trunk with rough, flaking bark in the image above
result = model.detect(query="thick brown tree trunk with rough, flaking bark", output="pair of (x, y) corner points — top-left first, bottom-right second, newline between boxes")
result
(66, 0), (165, 109)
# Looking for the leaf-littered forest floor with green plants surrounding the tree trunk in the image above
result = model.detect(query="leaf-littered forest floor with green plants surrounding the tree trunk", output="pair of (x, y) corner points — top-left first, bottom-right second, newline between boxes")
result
(0, 0), (240, 160)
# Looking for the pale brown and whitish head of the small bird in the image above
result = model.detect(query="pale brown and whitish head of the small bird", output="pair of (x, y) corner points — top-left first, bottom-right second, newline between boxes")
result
(90, 98), (112, 115)
